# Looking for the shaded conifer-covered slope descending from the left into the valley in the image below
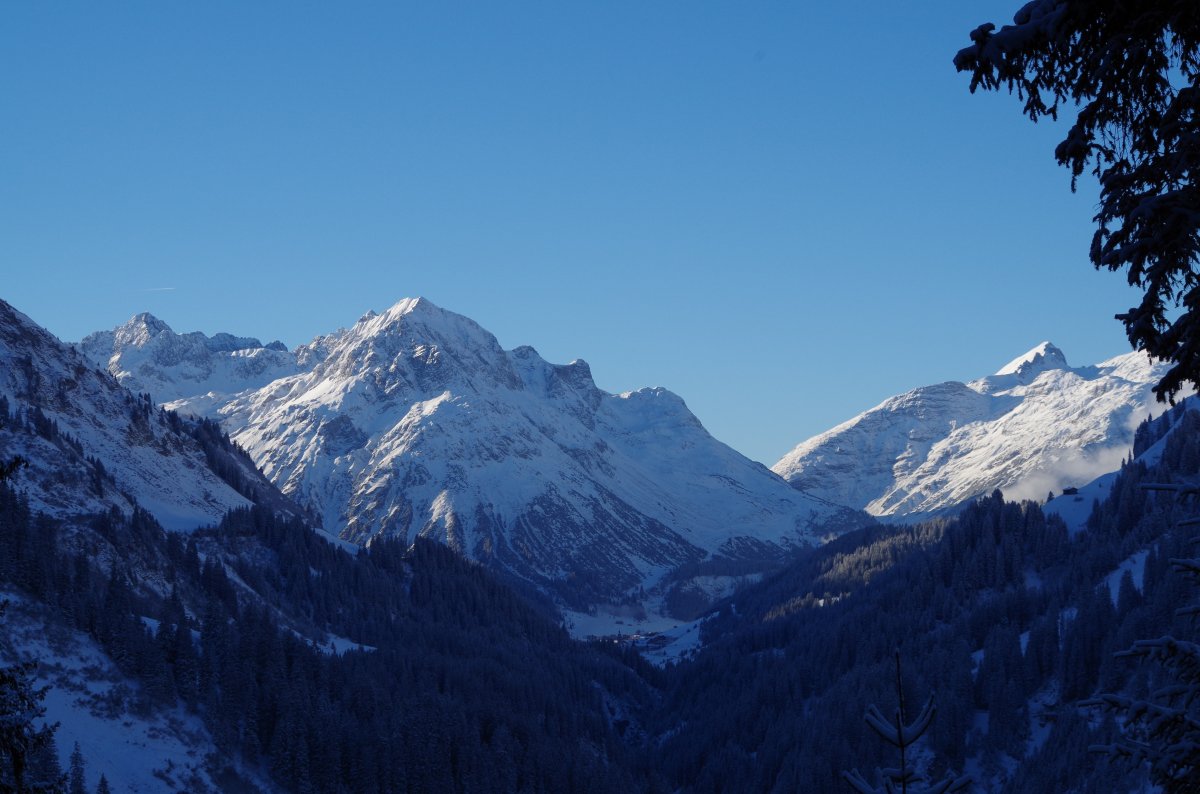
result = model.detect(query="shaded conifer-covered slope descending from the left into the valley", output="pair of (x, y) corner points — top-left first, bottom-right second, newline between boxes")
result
(0, 450), (658, 794)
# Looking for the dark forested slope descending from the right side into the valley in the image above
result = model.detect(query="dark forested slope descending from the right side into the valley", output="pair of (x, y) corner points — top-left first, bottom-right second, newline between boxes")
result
(650, 399), (1200, 793)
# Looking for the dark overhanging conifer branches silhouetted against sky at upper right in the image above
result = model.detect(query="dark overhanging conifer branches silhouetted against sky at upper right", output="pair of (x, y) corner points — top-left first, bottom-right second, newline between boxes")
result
(954, 0), (1200, 399)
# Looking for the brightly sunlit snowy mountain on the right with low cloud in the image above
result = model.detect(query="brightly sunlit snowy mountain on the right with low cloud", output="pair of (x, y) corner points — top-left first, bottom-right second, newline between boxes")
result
(772, 342), (1164, 518)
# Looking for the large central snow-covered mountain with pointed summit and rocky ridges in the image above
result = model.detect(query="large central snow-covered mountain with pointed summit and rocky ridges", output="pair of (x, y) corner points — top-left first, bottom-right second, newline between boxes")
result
(83, 299), (865, 601)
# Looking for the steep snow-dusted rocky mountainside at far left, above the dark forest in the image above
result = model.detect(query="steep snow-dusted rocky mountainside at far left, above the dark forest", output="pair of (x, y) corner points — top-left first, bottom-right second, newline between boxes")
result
(0, 301), (283, 529)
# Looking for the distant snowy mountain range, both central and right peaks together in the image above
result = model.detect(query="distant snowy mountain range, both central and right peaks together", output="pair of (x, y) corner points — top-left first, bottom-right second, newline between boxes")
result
(56, 299), (1160, 607)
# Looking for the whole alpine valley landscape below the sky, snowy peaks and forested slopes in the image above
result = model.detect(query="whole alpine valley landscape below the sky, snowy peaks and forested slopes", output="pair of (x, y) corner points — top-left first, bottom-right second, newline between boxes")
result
(0, 293), (1200, 794)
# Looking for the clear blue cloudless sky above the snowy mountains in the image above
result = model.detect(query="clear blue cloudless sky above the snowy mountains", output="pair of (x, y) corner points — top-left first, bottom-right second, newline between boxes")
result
(0, 0), (1134, 464)
